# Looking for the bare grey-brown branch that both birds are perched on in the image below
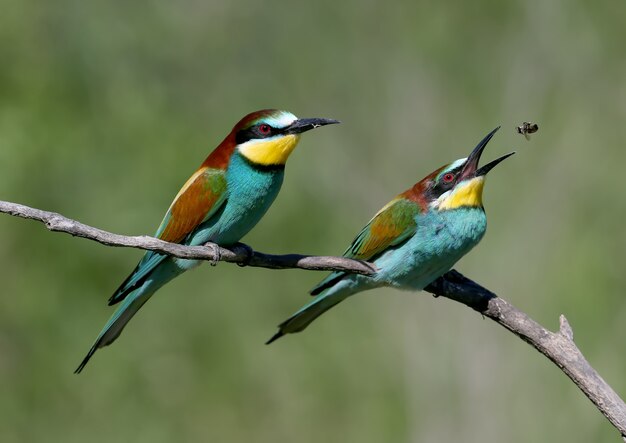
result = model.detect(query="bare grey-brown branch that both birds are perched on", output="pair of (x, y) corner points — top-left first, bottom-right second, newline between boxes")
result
(0, 201), (626, 442)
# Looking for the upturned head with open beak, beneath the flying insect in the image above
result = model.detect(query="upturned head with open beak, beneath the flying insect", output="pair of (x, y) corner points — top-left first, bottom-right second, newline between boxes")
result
(411, 127), (515, 211)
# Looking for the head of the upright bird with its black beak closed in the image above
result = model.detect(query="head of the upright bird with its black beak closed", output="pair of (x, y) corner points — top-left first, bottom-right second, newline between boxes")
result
(231, 109), (339, 166)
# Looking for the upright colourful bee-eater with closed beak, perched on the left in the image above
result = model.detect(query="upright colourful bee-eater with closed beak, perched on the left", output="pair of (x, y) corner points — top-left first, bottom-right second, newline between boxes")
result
(75, 109), (339, 373)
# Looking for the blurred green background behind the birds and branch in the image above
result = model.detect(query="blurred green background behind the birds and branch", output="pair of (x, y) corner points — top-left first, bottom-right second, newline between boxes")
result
(0, 0), (626, 443)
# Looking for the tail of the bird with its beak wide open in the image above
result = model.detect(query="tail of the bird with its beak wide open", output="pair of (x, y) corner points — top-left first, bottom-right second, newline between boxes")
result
(265, 280), (355, 345)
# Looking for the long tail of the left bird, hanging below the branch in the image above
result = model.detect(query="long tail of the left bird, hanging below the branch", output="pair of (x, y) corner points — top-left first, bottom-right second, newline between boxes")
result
(74, 261), (183, 374)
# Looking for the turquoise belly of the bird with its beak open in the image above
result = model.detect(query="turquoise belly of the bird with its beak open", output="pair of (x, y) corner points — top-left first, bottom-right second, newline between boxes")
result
(375, 209), (486, 290)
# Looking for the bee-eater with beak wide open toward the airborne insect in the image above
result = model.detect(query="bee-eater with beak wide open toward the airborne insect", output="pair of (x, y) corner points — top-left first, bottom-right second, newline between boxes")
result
(267, 127), (514, 344)
